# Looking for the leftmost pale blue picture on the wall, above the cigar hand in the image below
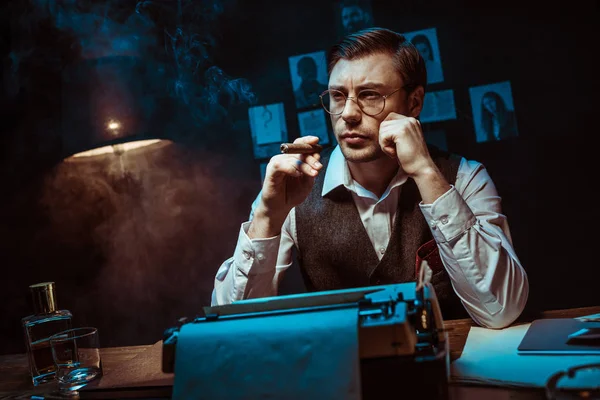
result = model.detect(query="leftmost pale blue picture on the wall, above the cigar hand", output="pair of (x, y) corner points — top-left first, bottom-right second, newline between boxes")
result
(248, 103), (288, 158)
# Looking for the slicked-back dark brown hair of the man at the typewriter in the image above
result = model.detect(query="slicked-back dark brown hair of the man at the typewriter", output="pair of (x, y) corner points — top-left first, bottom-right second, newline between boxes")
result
(327, 28), (427, 88)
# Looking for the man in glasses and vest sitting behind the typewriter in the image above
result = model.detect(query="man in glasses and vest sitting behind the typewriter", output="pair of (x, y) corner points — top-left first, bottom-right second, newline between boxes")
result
(212, 28), (529, 328)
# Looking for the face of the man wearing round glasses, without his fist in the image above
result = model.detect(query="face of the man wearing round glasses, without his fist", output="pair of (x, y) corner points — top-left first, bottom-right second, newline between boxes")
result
(329, 54), (414, 162)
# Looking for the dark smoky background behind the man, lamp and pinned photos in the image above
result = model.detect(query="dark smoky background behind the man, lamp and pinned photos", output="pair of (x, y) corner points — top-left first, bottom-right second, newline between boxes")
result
(0, 0), (599, 353)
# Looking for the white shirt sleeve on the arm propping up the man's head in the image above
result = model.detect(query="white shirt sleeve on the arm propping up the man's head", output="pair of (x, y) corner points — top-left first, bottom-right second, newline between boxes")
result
(420, 158), (529, 328)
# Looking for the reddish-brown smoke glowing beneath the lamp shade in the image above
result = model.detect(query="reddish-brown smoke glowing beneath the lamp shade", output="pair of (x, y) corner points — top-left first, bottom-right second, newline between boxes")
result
(42, 142), (256, 343)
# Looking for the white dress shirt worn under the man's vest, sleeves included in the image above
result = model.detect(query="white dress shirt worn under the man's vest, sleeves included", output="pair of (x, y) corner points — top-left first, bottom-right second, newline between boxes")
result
(211, 147), (529, 328)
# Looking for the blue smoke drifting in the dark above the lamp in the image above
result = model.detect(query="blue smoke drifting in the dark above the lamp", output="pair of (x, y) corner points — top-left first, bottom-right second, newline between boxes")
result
(4, 0), (255, 135)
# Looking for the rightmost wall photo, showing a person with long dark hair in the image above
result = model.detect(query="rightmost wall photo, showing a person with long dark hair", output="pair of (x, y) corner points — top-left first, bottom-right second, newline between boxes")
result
(469, 81), (519, 142)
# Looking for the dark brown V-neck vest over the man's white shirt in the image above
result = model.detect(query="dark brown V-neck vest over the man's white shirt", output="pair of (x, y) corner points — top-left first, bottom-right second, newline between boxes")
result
(296, 147), (467, 319)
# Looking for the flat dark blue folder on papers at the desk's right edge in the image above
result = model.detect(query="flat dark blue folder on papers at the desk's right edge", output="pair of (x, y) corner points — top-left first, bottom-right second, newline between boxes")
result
(517, 318), (600, 355)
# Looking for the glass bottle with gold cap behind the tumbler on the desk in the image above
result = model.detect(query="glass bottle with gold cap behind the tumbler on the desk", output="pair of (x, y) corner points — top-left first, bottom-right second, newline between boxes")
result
(21, 282), (72, 386)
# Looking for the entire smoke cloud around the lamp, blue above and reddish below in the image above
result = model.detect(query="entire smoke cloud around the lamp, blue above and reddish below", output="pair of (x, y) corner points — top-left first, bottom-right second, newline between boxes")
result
(0, 0), (259, 352)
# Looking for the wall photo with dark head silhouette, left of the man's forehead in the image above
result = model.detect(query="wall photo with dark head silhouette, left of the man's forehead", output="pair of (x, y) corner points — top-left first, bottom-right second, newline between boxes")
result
(289, 51), (328, 108)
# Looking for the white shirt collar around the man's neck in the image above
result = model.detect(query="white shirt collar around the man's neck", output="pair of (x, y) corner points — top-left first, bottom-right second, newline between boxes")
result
(321, 146), (408, 199)
